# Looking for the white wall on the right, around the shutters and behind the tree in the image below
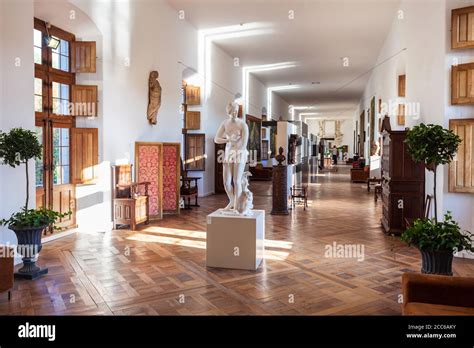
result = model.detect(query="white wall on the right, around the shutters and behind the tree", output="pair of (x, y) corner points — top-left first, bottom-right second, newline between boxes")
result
(355, 0), (474, 256)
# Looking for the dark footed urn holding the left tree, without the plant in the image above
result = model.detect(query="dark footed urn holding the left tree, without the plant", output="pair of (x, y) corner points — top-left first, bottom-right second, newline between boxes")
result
(10, 226), (48, 280)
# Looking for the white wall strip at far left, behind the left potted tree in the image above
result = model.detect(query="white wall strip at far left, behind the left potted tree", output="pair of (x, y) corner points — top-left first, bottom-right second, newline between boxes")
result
(0, 0), (35, 243)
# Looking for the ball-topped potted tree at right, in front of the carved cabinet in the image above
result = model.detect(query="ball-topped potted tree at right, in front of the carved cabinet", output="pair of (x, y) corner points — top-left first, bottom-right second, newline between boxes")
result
(401, 123), (474, 275)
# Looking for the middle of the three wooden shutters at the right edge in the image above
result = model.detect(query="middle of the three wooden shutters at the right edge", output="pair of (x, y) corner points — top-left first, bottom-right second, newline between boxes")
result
(451, 63), (474, 105)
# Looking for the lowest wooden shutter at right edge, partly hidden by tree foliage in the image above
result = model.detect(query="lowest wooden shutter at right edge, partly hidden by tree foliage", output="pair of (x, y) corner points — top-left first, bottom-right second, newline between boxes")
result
(449, 119), (474, 193)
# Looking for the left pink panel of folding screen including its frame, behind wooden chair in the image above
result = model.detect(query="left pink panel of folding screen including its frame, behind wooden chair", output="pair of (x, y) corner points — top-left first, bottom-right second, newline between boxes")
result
(135, 142), (163, 220)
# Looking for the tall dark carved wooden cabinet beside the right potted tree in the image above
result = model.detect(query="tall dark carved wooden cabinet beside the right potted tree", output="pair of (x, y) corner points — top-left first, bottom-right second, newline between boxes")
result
(381, 131), (425, 235)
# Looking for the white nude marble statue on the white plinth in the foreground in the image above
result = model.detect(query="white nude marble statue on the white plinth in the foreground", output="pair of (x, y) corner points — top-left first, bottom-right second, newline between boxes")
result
(214, 102), (252, 214)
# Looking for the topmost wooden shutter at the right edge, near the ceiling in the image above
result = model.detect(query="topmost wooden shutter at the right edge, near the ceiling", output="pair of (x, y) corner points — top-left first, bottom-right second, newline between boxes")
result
(451, 6), (474, 49)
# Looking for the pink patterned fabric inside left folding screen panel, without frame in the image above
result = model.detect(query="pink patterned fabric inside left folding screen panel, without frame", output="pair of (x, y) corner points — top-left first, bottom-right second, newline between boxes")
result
(136, 144), (162, 217)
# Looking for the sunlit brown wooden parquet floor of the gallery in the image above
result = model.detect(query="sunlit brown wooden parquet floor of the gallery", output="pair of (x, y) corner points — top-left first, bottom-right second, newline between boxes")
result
(0, 167), (474, 315)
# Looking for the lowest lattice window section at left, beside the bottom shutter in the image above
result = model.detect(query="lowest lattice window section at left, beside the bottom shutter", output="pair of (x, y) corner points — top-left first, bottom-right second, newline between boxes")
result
(53, 128), (70, 185)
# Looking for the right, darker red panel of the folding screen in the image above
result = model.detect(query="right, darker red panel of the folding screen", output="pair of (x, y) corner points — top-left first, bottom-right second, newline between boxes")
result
(163, 143), (181, 214)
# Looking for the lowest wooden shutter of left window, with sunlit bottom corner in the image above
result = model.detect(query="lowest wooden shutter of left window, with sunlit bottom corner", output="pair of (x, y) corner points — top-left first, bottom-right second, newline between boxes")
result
(71, 128), (99, 184)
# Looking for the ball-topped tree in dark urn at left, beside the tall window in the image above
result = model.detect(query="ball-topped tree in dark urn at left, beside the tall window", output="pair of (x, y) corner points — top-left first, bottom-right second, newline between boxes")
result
(0, 128), (71, 279)
